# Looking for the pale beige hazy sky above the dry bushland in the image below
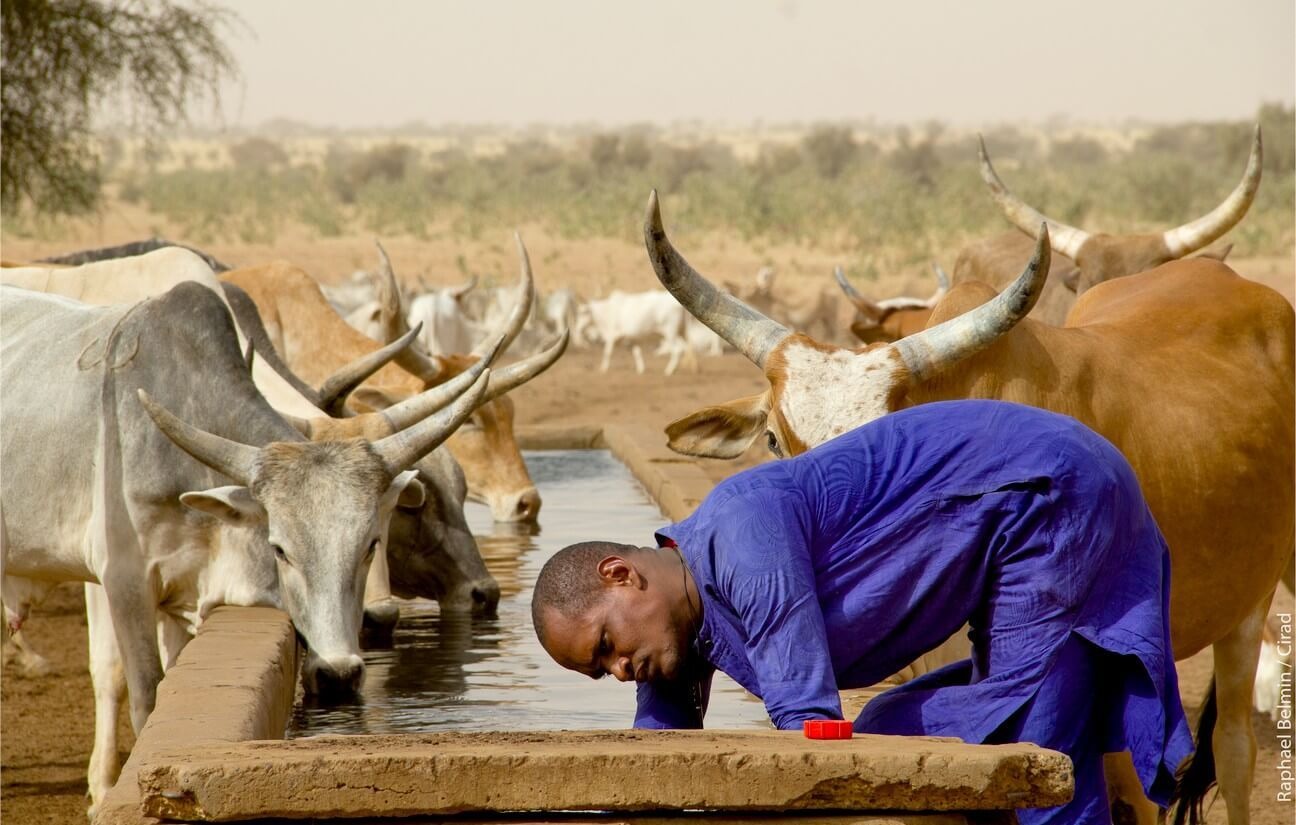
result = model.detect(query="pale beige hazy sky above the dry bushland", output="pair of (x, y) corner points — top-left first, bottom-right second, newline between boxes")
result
(209, 0), (1296, 127)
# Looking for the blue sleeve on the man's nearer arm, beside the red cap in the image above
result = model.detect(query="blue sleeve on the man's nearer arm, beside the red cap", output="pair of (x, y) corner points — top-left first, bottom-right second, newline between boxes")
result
(714, 488), (841, 730)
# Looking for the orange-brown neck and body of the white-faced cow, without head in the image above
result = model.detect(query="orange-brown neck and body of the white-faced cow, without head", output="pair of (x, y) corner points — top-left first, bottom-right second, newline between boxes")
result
(910, 259), (1296, 657)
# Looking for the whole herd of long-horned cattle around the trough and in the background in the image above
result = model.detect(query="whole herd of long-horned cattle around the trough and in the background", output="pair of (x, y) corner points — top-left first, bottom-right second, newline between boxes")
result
(0, 128), (1296, 824)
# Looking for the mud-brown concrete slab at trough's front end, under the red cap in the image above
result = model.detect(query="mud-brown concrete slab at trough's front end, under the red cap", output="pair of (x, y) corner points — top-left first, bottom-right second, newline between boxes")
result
(139, 730), (1072, 821)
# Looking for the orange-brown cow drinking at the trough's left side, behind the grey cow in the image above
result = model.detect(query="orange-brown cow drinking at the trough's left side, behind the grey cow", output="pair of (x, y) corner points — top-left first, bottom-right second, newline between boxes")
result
(222, 241), (566, 522)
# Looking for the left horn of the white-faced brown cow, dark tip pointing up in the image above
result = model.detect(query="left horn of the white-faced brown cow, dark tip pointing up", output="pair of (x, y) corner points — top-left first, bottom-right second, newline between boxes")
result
(644, 189), (792, 367)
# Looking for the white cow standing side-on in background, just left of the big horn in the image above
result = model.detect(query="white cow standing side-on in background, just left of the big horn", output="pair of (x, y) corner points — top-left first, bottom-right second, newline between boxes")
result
(578, 290), (697, 376)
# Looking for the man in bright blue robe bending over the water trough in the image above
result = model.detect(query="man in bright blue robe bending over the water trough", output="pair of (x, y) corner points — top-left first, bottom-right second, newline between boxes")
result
(531, 401), (1192, 824)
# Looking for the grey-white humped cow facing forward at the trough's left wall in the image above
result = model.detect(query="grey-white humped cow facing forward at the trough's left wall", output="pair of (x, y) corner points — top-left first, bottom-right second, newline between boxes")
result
(0, 282), (489, 803)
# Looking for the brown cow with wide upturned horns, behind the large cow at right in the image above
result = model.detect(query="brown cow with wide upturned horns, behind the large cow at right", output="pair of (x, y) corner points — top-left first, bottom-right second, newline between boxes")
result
(969, 126), (1264, 326)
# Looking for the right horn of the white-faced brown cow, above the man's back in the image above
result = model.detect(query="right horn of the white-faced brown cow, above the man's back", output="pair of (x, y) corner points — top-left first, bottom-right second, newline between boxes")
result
(890, 223), (1052, 381)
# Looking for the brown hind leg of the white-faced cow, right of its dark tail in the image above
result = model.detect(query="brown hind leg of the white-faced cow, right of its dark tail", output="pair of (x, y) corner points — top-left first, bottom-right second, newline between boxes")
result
(1212, 598), (1269, 825)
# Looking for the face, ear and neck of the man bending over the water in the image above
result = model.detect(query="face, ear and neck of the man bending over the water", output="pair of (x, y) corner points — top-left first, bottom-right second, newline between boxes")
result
(540, 556), (689, 681)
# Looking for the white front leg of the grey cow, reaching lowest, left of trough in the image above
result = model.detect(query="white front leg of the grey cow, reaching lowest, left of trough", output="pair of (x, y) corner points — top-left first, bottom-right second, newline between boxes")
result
(86, 584), (126, 816)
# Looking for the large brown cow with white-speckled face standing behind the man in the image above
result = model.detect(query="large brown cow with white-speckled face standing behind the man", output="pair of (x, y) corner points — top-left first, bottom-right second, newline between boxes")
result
(644, 193), (1296, 822)
